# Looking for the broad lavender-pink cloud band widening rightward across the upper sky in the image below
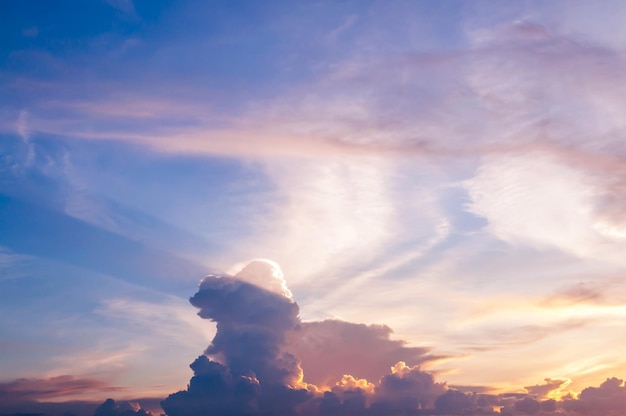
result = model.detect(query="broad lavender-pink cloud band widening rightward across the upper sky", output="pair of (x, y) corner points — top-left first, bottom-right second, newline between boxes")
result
(11, 15), (624, 165)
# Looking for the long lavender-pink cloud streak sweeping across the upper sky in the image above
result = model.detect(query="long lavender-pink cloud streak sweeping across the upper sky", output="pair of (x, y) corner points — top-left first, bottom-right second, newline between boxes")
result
(6, 22), (623, 168)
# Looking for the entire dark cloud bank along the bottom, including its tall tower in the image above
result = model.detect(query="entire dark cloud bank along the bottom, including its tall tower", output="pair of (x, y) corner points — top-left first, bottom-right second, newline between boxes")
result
(161, 260), (626, 416)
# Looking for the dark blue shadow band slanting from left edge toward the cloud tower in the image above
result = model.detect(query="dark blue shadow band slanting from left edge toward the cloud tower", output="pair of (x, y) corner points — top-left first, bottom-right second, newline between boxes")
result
(0, 193), (203, 282)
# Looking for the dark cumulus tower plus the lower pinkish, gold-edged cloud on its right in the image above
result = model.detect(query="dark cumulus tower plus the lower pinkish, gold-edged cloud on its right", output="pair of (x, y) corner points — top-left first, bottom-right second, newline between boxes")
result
(161, 260), (447, 416)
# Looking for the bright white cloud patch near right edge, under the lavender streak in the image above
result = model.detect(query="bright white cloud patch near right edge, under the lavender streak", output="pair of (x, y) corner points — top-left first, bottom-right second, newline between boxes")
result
(465, 153), (622, 260)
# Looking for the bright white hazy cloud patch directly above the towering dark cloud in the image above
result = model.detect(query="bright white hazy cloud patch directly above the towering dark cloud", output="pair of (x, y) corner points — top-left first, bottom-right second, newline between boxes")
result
(251, 157), (397, 287)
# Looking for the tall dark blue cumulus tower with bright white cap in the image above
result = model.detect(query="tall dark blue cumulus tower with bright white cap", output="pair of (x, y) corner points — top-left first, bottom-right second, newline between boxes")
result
(162, 261), (310, 416)
